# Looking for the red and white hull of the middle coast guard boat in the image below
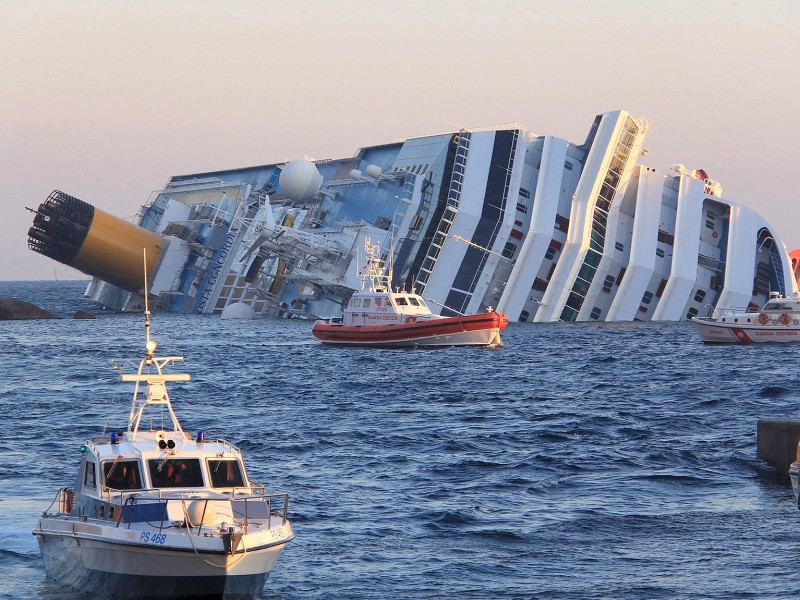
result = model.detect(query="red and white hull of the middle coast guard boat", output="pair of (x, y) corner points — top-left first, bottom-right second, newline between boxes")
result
(311, 312), (508, 347)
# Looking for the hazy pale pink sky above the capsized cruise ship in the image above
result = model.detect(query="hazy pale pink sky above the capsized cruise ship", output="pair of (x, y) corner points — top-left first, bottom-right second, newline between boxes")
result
(0, 0), (800, 280)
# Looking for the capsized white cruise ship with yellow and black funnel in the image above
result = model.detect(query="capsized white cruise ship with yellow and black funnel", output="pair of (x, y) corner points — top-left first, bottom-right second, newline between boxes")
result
(28, 110), (797, 322)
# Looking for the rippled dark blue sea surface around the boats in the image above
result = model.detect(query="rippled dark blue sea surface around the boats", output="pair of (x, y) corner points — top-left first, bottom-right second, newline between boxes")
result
(0, 282), (800, 600)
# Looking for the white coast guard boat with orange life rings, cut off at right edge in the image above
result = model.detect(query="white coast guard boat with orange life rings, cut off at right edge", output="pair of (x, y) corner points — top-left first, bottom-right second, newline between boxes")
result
(692, 293), (800, 344)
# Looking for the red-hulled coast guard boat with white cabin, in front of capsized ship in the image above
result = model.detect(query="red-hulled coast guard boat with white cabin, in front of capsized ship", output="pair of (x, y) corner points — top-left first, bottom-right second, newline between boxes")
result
(311, 238), (508, 347)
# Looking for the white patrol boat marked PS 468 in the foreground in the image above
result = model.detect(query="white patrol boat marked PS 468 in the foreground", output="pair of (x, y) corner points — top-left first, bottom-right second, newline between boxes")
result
(33, 292), (294, 598)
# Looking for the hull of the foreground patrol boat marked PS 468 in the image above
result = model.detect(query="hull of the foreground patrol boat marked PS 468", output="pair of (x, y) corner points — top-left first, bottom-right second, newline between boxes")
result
(34, 519), (289, 599)
